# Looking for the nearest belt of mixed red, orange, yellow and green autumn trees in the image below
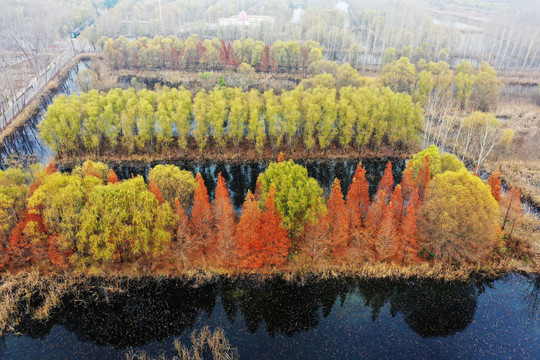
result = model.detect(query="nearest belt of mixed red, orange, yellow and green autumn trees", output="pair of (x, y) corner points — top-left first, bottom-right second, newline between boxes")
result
(0, 146), (523, 271)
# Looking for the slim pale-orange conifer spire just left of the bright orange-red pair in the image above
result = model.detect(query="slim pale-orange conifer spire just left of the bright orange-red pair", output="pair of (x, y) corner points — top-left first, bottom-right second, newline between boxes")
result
(212, 173), (236, 264)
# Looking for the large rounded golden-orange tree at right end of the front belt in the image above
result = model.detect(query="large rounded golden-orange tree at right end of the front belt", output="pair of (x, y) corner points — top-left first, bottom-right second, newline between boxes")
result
(418, 169), (499, 263)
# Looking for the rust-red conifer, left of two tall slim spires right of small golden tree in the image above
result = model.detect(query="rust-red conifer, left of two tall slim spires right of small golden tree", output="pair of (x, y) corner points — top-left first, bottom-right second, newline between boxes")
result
(189, 174), (214, 256)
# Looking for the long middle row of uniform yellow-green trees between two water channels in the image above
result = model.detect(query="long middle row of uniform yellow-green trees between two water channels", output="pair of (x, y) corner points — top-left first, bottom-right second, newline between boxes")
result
(39, 85), (423, 155)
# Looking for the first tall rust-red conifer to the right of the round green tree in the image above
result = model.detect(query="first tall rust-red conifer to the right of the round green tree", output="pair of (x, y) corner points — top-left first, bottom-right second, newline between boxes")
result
(326, 179), (350, 254)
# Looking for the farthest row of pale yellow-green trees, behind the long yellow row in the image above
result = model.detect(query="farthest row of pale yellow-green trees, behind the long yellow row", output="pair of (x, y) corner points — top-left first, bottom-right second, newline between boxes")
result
(103, 35), (334, 72)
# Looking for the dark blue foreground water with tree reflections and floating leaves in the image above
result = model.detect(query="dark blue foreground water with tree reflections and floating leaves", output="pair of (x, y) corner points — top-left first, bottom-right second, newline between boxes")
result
(0, 274), (540, 359)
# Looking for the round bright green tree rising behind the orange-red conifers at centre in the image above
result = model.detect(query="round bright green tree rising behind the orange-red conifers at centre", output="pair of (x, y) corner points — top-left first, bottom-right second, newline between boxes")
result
(261, 160), (325, 238)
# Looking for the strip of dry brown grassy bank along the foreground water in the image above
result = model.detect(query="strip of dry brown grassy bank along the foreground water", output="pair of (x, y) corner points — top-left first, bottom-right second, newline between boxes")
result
(0, 259), (540, 334)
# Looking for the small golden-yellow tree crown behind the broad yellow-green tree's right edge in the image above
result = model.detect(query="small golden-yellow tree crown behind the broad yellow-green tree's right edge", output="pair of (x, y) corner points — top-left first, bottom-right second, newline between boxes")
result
(148, 165), (196, 209)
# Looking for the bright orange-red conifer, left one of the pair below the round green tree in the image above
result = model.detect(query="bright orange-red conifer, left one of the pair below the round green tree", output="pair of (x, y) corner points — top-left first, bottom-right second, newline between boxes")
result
(236, 191), (265, 269)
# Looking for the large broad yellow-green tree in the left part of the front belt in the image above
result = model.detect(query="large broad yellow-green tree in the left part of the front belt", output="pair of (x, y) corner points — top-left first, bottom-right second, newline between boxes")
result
(77, 176), (178, 264)
